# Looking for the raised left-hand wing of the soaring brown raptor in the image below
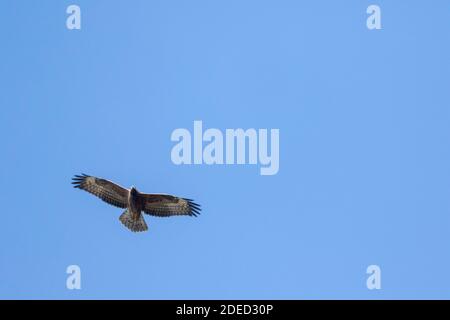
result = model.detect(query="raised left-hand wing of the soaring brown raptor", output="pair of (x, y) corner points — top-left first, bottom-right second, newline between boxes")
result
(72, 174), (128, 208)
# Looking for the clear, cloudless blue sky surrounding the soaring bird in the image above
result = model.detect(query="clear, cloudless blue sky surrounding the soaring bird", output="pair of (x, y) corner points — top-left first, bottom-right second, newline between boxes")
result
(0, 0), (450, 299)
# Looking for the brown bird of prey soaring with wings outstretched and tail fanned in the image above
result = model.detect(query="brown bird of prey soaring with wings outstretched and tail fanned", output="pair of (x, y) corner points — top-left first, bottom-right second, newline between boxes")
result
(72, 174), (201, 232)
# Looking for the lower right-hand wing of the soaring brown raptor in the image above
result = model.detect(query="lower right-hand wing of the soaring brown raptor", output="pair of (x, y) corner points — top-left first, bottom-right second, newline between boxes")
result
(139, 193), (201, 217)
